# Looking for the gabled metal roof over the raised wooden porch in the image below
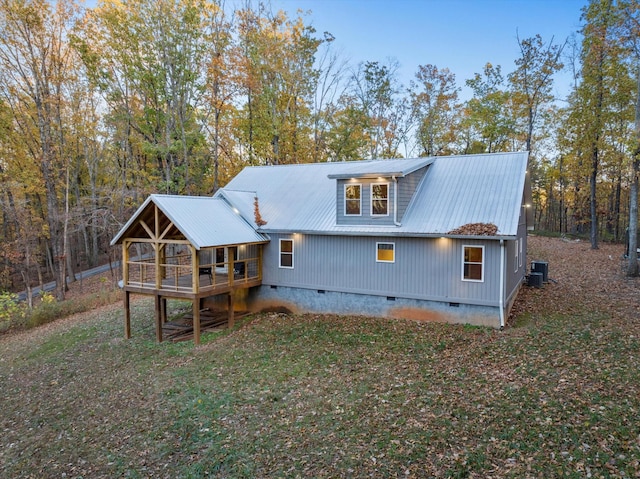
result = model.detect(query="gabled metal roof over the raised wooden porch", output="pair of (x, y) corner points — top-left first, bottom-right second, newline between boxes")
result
(111, 195), (268, 249)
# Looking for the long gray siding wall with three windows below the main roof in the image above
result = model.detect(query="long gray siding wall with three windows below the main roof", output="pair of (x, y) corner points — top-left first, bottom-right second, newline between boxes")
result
(263, 234), (500, 306)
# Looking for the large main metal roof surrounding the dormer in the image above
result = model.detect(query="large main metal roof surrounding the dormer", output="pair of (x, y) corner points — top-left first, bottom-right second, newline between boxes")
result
(222, 152), (528, 237)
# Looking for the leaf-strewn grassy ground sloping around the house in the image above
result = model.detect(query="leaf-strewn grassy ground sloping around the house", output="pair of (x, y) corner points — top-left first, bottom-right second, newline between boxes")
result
(0, 237), (640, 478)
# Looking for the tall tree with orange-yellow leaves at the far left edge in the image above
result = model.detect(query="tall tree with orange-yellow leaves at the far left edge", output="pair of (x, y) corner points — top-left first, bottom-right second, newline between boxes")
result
(0, 0), (77, 300)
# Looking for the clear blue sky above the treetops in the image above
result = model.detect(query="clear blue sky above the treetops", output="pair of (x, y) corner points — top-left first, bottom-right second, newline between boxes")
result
(271, 0), (587, 98)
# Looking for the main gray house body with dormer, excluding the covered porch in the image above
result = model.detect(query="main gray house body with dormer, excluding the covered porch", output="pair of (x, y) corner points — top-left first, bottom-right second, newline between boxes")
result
(210, 153), (531, 328)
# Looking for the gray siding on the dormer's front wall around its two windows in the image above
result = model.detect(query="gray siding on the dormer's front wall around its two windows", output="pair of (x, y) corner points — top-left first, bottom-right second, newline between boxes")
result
(336, 178), (395, 226)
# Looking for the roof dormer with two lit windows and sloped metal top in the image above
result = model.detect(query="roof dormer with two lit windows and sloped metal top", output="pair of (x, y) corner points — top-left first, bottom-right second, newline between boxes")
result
(328, 158), (433, 226)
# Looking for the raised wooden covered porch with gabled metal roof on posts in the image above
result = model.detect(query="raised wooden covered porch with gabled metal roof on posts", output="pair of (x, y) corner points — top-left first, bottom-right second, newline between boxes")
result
(112, 195), (268, 344)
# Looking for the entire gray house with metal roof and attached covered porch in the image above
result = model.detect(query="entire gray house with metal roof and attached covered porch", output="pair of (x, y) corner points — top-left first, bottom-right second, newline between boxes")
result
(112, 152), (532, 341)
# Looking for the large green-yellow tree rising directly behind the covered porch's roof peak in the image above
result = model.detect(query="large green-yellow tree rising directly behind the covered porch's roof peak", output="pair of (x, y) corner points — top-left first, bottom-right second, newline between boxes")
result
(75, 0), (209, 197)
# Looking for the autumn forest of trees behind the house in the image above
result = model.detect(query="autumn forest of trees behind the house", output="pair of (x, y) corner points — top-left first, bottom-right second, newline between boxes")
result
(0, 0), (640, 300)
